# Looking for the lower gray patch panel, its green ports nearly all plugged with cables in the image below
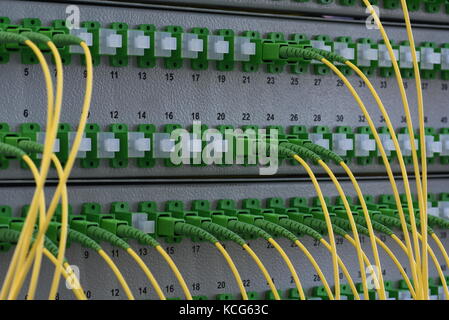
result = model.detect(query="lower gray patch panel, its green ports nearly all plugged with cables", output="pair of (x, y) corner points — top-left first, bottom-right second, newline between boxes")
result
(0, 180), (448, 299)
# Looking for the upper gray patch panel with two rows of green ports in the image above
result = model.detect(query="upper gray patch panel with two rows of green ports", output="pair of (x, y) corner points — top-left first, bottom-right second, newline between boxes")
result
(1, 1), (448, 178)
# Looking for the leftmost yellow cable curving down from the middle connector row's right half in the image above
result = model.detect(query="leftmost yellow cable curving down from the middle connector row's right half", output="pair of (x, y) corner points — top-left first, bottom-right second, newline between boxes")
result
(293, 154), (340, 300)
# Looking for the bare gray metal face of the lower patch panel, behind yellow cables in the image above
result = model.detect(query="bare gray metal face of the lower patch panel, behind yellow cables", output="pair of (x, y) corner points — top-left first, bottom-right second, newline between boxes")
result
(0, 179), (449, 299)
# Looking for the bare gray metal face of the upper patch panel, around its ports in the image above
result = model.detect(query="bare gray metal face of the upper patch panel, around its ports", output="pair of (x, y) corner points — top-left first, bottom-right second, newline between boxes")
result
(0, 1), (449, 179)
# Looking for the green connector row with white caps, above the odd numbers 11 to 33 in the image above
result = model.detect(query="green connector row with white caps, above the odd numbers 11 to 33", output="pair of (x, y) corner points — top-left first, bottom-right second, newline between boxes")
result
(0, 16), (449, 80)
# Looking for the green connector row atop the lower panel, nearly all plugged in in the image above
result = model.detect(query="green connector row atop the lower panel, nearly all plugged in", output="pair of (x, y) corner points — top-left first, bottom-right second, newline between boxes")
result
(4, 193), (440, 242)
